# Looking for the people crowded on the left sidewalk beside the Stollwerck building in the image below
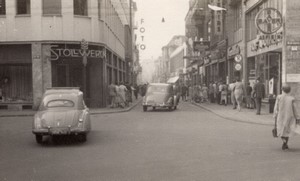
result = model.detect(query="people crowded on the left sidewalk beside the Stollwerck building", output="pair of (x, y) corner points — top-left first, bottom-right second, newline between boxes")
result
(108, 82), (146, 108)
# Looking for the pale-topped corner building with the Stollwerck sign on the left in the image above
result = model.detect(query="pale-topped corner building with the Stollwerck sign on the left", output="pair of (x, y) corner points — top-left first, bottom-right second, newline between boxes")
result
(0, 0), (136, 108)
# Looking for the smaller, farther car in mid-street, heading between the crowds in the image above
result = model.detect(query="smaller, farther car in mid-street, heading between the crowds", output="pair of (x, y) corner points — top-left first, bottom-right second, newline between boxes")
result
(143, 83), (177, 111)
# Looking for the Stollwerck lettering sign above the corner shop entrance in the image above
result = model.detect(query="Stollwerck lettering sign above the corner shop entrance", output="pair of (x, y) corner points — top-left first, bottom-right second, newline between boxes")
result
(50, 42), (105, 60)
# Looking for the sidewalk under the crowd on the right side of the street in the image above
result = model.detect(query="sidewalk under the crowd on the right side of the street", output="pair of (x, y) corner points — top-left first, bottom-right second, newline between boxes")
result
(192, 102), (274, 125)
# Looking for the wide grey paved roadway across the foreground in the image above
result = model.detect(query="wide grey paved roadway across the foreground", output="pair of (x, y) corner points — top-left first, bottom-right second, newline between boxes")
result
(0, 103), (300, 181)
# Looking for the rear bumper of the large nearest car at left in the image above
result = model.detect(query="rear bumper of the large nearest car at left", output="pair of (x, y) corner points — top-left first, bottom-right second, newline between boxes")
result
(32, 128), (89, 135)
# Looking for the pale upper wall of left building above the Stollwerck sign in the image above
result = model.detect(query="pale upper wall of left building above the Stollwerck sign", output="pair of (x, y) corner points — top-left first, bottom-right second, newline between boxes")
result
(0, 0), (125, 58)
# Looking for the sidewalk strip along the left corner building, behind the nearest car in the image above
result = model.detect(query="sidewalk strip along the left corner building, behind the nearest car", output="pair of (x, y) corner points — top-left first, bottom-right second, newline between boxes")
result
(0, 97), (142, 117)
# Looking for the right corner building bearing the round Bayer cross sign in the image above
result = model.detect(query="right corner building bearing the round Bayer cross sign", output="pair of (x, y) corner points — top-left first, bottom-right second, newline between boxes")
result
(243, 0), (300, 100)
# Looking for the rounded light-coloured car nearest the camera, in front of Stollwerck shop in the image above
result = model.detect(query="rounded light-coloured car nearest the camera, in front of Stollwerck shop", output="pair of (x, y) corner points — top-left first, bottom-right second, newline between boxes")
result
(32, 88), (91, 144)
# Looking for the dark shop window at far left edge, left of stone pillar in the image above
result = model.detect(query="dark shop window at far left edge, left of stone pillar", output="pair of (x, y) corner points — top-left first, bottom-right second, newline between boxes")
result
(0, 44), (33, 110)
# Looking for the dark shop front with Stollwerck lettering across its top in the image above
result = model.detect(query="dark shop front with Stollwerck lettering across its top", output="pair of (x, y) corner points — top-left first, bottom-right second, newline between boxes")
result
(50, 43), (111, 107)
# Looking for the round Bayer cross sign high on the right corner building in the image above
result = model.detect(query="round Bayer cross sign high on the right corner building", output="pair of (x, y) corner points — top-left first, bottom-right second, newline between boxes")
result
(255, 8), (283, 34)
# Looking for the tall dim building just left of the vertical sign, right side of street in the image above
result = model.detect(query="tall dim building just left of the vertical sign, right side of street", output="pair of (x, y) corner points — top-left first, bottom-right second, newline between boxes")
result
(185, 0), (212, 85)
